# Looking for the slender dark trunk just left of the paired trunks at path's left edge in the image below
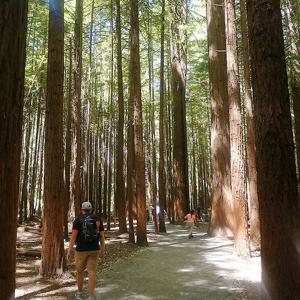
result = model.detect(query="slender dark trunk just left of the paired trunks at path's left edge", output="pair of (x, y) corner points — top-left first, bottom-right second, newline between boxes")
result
(115, 0), (127, 233)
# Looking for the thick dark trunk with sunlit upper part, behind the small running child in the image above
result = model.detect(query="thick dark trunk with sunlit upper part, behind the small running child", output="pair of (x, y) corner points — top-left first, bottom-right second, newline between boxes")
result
(171, 0), (189, 219)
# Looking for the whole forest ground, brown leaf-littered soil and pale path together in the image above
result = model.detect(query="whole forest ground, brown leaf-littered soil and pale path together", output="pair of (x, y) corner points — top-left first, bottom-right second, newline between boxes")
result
(16, 221), (260, 300)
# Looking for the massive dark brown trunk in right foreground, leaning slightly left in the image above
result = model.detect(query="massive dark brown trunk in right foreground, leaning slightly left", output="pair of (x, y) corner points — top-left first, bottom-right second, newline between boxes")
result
(247, 0), (300, 300)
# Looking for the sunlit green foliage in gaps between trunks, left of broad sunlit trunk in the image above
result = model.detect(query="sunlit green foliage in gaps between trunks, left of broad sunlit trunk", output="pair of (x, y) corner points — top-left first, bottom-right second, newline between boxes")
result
(24, 0), (210, 206)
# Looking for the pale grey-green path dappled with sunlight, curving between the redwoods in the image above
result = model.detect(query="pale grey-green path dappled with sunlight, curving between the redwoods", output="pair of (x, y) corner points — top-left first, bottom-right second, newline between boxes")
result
(96, 226), (260, 300)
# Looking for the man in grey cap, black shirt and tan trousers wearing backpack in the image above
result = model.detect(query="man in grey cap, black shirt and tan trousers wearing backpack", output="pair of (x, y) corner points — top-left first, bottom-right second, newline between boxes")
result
(67, 202), (105, 300)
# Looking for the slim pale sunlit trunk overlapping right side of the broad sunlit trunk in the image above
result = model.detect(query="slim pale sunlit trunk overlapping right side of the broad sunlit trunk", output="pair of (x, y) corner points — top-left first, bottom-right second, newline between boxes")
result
(225, 0), (250, 257)
